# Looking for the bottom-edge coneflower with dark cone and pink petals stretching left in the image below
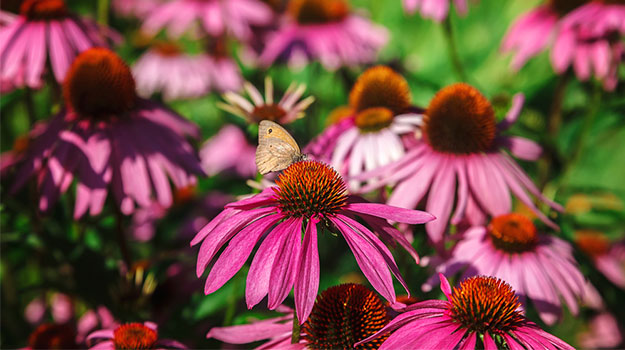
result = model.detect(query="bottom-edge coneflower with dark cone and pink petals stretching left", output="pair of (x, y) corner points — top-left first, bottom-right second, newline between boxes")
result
(206, 283), (390, 349)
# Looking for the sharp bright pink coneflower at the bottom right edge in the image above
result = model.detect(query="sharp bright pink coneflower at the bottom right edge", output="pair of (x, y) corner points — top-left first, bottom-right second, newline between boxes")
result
(358, 274), (574, 350)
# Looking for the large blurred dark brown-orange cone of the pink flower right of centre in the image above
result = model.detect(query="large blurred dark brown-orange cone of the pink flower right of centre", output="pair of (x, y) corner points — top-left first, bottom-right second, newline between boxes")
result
(423, 83), (496, 154)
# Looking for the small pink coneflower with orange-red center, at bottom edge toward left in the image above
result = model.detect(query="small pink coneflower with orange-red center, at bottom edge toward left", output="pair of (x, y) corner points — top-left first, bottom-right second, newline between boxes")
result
(87, 322), (187, 350)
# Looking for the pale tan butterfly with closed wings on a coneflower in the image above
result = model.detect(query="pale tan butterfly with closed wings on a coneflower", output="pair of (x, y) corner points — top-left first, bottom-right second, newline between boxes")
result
(256, 120), (307, 175)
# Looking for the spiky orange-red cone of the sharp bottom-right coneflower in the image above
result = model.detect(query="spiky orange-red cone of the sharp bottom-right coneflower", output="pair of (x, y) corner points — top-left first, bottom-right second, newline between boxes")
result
(449, 276), (524, 334)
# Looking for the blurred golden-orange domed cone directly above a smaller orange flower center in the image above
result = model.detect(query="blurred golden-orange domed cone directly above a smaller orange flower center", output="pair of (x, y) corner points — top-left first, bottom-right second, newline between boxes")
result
(349, 66), (411, 115)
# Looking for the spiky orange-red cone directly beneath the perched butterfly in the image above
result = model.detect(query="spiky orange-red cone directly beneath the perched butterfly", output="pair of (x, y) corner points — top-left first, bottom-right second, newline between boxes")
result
(274, 160), (347, 217)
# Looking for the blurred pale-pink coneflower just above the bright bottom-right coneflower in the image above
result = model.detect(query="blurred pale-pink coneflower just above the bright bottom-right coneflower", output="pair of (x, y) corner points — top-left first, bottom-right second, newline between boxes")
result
(424, 213), (586, 324)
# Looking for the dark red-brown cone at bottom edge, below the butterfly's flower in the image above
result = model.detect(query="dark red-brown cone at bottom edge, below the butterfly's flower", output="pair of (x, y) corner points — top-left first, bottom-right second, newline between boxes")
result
(302, 283), (389, 349)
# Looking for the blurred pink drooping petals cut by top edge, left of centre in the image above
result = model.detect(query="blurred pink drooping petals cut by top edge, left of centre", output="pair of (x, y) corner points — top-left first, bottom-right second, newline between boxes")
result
(142, 0), (273, 40)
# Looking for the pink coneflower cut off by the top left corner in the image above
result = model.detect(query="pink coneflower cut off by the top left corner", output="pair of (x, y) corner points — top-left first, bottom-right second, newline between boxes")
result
(0, 0), (106, 88)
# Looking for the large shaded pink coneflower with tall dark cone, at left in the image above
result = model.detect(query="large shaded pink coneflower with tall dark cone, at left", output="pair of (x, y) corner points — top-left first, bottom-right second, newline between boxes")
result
(4, 48), (203, 218)
